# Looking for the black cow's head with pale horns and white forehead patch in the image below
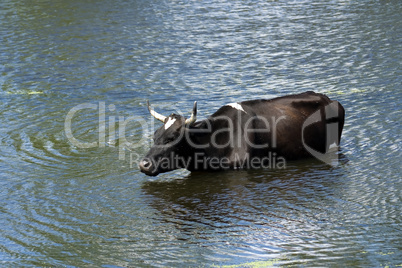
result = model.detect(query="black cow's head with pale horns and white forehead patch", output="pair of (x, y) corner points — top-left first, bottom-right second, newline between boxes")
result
(139, 101), (197, 176)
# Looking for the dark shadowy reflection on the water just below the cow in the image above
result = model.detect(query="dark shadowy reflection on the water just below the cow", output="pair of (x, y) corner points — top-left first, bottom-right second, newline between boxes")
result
(142, 156), (347, 231)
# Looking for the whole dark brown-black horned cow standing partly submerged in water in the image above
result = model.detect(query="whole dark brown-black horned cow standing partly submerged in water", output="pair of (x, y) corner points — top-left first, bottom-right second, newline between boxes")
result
(139, 91), (345, 176)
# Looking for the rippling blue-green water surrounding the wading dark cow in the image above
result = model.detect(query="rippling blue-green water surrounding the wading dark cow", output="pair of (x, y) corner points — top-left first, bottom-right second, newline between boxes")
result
(0, 0), (402, 267)
